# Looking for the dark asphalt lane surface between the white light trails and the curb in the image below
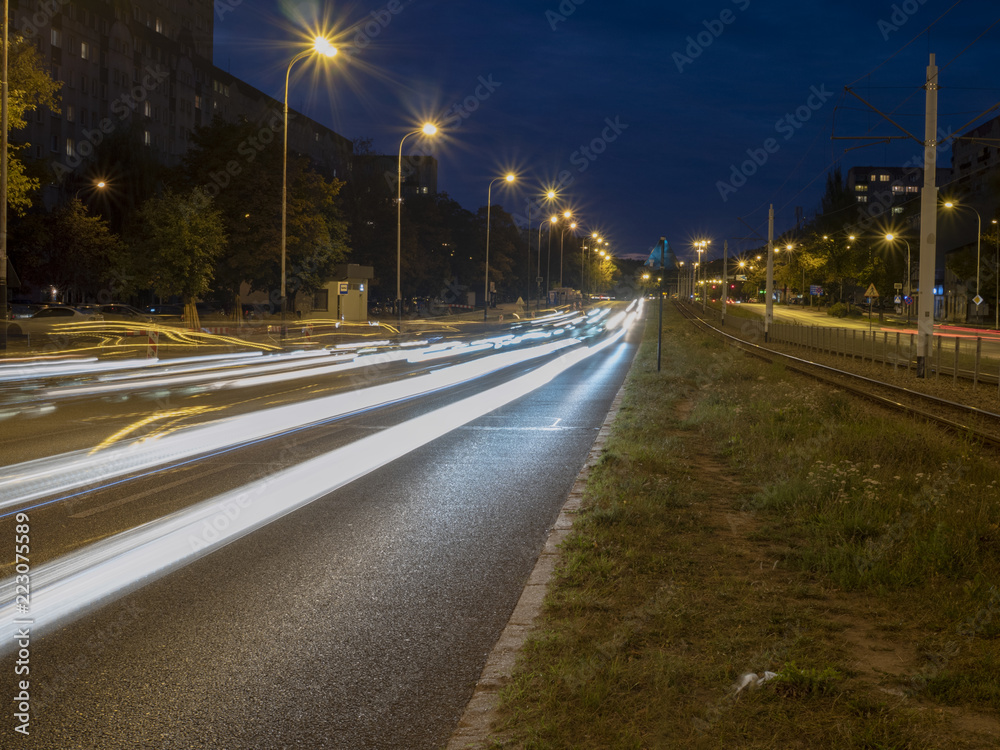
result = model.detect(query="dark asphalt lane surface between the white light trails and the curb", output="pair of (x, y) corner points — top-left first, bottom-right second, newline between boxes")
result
(0, 312), (641, 750)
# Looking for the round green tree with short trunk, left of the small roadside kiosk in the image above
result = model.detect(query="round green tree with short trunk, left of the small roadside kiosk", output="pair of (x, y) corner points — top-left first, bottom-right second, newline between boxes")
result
(129, 190), (226, 325)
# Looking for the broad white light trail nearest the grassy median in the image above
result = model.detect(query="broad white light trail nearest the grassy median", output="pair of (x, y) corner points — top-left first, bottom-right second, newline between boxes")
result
(0, 314), (640, 653)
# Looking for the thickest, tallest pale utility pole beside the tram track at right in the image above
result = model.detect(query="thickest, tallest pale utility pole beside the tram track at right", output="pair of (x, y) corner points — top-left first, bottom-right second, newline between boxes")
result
(917, 54), (938, 378)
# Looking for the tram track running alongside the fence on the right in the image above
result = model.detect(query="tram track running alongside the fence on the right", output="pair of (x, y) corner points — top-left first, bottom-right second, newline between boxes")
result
(675, 303), (1000, 450)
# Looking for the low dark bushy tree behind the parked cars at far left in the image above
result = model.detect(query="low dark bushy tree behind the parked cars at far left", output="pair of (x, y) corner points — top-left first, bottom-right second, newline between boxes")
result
(11, 199), (125, 302)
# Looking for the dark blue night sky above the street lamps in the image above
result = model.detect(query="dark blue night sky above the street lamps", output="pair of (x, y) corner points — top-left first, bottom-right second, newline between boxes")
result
(215, 0), (1000, 258)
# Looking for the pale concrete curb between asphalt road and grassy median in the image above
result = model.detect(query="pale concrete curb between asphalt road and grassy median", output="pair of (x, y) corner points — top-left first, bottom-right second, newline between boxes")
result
(446, 383), (625, 750)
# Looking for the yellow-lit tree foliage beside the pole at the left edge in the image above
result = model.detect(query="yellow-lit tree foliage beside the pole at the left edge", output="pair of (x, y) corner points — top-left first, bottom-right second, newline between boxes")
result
(7, 34), (62, 215)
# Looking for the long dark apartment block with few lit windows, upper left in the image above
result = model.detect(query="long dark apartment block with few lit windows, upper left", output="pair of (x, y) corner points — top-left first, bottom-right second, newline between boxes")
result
(10, 0), (352, 205)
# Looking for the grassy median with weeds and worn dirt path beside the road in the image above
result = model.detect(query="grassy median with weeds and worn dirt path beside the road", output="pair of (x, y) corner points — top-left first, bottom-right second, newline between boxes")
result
(493, 306), (1000, 749)
